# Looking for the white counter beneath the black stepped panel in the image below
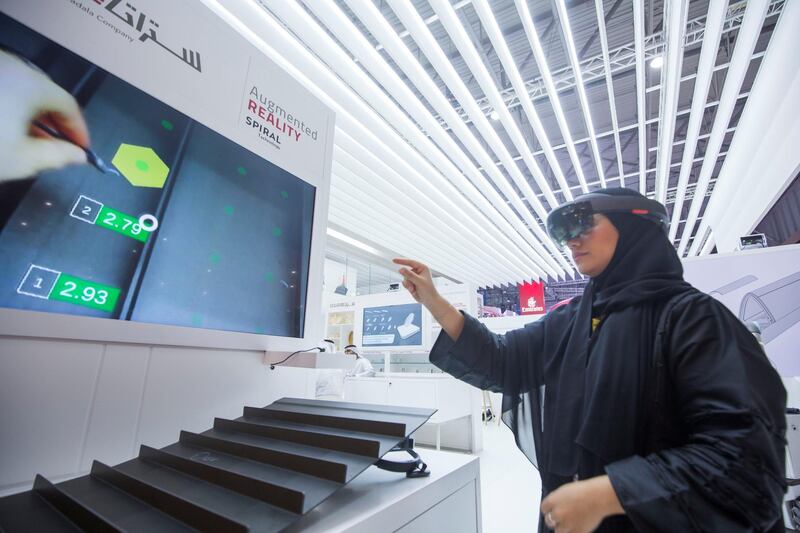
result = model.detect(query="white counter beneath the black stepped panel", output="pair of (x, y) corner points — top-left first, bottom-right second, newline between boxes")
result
(286, 450), (481, 533)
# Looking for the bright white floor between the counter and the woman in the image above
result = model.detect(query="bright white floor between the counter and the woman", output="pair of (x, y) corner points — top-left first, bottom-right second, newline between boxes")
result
(478, 420), (541, 533)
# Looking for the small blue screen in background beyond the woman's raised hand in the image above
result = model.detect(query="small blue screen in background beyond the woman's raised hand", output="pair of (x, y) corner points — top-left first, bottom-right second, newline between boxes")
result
(361, 303), (422, 349)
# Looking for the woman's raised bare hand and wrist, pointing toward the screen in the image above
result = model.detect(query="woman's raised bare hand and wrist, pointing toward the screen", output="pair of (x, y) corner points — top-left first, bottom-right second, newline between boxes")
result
(393, 258), (464, 340)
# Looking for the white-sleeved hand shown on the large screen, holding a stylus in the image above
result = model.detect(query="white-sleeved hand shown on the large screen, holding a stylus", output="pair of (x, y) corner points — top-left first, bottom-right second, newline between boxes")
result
(0, 50), (89, 181)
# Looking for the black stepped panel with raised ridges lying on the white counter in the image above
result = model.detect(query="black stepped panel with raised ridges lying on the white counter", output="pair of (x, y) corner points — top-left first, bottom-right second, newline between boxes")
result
(0, 398), (435, 533)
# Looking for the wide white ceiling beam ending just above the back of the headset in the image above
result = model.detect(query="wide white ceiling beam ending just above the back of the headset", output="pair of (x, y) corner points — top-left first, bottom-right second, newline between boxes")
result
(655, 0), (689, 203)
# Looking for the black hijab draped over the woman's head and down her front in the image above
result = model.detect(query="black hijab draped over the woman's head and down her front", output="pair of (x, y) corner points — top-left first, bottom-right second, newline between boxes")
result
(503, 189), (691, 482)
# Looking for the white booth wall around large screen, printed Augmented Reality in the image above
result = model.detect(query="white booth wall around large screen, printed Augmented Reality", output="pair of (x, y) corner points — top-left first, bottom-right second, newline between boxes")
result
(0, 0), (334, 495)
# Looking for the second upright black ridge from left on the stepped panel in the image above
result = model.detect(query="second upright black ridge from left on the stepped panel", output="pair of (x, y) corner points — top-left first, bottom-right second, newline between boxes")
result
(91, 461), (242, 532)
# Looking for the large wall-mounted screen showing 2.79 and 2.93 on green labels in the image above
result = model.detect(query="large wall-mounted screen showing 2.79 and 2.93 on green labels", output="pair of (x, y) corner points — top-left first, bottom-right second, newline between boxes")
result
(0, 14), (316, 337)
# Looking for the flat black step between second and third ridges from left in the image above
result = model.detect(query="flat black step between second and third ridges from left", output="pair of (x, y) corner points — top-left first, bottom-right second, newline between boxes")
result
(114, 457), (300, 531)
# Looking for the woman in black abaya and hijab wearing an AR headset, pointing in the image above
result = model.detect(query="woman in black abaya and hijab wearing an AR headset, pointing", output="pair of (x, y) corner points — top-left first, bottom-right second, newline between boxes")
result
(395, 189), (786, 533)
